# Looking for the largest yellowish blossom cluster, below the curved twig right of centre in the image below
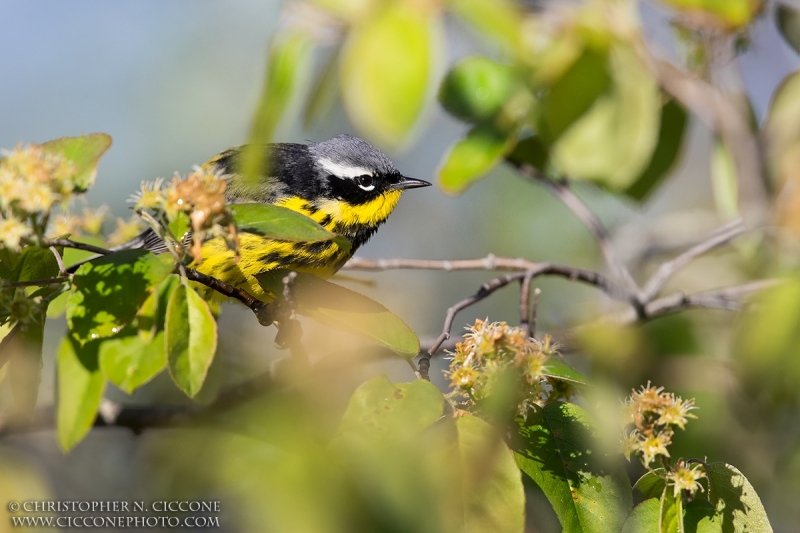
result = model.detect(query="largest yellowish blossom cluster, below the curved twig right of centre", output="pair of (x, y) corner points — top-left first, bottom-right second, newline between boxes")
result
(445, 320), (572, 417)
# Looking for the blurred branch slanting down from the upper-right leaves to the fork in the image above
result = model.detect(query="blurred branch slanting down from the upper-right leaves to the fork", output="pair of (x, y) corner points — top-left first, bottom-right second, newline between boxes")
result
(517, 164), (639, 302)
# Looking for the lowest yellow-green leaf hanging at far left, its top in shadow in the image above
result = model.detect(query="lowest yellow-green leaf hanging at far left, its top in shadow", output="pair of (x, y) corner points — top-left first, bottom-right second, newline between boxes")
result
(56, 335), (105, 451)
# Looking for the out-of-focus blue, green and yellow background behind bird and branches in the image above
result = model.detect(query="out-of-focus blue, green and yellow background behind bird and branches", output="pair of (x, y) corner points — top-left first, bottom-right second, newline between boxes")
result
(0, 0), (800, 532)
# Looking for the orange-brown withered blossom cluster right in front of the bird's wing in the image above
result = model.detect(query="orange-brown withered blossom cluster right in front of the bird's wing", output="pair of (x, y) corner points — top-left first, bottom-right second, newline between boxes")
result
(133, 167), (239, 263)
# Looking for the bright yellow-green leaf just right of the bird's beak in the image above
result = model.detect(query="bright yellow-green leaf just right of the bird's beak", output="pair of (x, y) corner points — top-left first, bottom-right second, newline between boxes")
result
(439, 124), (517, 194)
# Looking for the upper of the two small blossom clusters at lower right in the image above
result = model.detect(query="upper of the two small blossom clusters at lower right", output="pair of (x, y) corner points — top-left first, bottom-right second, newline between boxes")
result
(623, 382), (697, 468)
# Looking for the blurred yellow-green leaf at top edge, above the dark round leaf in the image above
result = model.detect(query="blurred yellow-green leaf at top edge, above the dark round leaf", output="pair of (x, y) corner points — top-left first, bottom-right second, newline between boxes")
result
(449, 0), (523, 48)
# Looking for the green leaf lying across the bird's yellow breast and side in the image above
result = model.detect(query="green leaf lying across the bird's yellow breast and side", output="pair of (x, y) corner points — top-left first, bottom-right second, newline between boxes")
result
(230, 204), (350, 251)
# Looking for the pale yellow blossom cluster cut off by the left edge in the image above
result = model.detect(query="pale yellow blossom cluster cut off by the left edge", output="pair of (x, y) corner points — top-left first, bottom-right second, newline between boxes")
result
(0, 144), (78, 251)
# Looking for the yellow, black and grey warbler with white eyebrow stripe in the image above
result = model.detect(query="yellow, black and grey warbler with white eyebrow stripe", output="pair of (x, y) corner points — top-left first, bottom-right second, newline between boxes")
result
(91, 134), (431, 304)
